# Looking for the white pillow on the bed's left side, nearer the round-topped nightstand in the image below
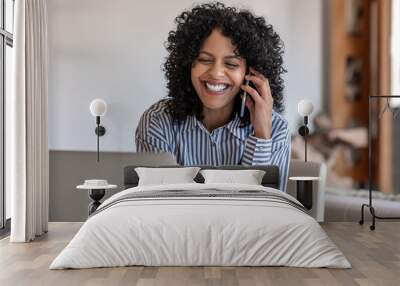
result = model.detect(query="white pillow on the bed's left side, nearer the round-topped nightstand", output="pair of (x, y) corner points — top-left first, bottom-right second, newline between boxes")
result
(135, 167), (200, 186)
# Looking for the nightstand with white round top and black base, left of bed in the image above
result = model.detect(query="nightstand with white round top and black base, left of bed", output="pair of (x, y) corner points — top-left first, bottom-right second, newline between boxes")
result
(76, 180), (117, 216)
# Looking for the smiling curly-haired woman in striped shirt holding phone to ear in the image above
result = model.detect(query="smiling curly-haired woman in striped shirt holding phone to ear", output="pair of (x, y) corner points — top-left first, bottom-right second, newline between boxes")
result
(136, 2), (290, 191)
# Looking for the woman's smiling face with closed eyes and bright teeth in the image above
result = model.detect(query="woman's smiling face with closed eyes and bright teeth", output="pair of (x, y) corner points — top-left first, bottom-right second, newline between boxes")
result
(191, 29), (246, 117)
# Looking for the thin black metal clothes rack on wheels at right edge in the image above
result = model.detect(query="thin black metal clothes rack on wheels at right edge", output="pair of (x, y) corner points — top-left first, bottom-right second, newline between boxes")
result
(359, 95), (400, 230)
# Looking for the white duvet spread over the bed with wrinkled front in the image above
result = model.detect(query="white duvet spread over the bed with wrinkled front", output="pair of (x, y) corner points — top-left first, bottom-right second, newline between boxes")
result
(50, 184), (351, 269)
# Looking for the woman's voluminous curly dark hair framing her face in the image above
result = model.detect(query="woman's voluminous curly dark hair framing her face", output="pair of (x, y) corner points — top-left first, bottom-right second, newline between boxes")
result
(163, 2), (286, 124)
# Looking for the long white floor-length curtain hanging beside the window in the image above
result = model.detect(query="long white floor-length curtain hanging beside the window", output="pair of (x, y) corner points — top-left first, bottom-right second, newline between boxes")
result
(6, 0), (49, 242)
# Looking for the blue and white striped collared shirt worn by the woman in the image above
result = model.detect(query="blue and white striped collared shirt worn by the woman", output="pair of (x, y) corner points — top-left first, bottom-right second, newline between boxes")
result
(136, 99), (290, 191)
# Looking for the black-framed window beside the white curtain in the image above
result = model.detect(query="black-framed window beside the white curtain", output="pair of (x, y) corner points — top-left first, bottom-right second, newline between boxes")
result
(0, 0), (14, 231)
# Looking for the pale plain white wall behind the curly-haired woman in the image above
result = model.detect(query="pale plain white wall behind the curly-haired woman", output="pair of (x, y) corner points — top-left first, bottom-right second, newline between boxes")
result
(47, 0), (322, 151)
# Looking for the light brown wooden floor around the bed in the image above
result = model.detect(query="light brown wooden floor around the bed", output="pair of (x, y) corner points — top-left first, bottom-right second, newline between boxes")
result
(0, 221), (400, 286)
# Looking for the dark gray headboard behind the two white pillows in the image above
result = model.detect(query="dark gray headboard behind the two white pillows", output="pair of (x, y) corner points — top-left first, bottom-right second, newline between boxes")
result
(124, 165), (279, 189)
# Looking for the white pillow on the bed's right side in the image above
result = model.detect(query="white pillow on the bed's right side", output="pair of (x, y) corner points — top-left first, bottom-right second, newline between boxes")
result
(200, 169), (265, 185)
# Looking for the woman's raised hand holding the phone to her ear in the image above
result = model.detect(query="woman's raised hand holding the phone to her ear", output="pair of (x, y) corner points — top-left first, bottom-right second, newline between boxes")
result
(241, 68), (274, 139)
